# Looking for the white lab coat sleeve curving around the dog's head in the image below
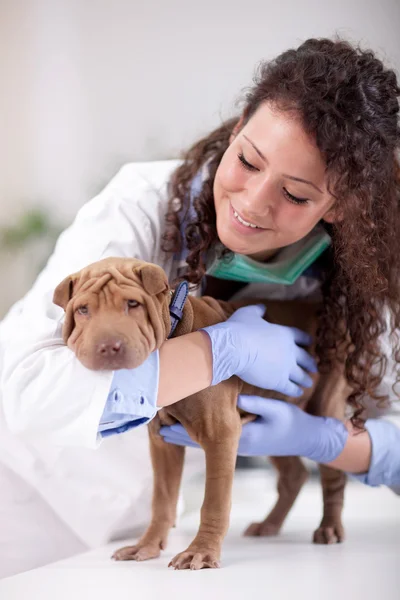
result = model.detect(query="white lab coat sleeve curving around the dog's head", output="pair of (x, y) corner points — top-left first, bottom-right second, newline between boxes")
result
(0, 161), (172, 448)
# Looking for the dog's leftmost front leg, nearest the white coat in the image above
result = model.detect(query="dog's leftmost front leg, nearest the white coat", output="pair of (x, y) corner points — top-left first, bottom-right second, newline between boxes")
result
(113, 422), (185, 561)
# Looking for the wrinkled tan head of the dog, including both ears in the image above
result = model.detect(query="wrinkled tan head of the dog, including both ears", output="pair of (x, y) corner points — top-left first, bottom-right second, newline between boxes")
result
(53, 258), (170, 370)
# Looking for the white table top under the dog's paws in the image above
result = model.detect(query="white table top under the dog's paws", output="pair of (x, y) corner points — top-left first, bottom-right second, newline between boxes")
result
(0, 471), (400, 600)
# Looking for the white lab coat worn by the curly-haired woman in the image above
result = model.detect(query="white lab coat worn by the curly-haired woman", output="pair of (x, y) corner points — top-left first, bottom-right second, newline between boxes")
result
(0, 161), (203, 576)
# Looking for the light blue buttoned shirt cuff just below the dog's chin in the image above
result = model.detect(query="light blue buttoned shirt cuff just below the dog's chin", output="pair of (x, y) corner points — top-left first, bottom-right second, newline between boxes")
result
(99, 352), (159, 437)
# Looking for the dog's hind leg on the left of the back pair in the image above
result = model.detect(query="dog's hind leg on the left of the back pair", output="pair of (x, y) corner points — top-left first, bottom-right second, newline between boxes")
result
(244, 456), (308, 537)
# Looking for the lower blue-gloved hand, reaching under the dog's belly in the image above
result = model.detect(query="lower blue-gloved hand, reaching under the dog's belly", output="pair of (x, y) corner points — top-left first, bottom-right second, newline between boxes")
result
(160, 395), (348, 463)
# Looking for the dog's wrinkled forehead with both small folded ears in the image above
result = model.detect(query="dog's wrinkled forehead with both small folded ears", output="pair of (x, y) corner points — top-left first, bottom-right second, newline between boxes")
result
(53, 258), (168, 309)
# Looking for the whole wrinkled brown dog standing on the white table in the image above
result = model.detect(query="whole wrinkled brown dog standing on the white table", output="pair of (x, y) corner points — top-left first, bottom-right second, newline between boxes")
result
(54, 258), (349, 569)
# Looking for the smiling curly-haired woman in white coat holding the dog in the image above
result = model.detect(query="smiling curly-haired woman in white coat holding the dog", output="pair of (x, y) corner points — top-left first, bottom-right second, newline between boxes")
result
(0, 40), (400, 575)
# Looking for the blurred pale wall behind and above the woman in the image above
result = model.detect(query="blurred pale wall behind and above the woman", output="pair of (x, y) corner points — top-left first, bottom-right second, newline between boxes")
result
(0, 0), (400, 310)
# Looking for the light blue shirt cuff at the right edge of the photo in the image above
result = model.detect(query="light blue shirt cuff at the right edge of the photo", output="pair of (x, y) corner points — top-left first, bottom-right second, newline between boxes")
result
(352, 419), (400, 494)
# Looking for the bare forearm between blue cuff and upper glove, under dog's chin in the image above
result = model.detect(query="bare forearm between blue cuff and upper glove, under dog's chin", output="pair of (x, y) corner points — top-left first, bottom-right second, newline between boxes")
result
(157, 331), (213, 406)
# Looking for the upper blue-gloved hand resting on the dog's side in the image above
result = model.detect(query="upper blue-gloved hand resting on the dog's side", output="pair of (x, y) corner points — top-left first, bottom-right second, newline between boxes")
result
(203, 304), (317, 396)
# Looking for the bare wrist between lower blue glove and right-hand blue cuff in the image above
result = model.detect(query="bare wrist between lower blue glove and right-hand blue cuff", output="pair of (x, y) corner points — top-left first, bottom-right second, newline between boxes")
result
(328, 421), (372, 473)
